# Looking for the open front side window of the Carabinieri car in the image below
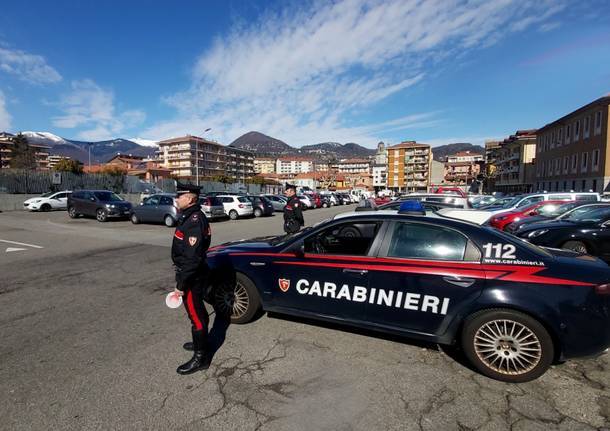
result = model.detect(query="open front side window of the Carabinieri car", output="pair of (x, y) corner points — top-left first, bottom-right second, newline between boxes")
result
(304, 222), (381, 256)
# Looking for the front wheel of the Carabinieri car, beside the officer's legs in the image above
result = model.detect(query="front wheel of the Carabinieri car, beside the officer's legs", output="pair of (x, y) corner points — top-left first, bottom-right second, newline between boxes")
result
(214, 272), (261, 325)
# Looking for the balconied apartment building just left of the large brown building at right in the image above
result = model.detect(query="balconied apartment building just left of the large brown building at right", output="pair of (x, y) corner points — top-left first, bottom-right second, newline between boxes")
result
(495, 129), (537, 193)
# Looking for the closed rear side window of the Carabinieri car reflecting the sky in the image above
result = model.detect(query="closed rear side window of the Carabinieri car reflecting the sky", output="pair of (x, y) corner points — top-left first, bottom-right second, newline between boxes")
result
(388, 222), (468, 260)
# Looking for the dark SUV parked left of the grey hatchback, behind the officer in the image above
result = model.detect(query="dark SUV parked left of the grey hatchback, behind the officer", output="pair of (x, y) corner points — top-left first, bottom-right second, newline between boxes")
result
(68, 190), (131, 222)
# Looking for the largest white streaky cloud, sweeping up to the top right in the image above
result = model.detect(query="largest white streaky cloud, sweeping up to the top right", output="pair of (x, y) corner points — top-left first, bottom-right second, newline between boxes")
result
(144, 0), (562, 146)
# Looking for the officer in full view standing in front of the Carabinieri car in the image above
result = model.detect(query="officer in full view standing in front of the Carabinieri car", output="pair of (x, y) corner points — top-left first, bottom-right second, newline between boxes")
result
(172, 184), (212, 374)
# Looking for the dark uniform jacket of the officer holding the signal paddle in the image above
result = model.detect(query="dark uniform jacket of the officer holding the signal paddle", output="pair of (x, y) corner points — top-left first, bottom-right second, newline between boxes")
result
(172, 204), (211, 291)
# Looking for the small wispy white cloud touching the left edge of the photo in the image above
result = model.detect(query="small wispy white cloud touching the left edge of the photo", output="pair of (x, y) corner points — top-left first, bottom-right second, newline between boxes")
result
(0, 46), (62, 84)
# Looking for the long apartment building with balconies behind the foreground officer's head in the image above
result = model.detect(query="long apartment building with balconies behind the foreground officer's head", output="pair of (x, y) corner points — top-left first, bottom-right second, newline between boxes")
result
(157, 135), (254, 183)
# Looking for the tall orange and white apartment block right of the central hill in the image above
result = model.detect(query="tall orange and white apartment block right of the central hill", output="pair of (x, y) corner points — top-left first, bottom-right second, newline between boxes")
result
(387, 141), (432, 192)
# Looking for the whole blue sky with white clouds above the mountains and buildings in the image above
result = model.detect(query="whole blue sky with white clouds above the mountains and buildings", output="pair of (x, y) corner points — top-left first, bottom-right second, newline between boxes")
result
(0, 0), (610, 147)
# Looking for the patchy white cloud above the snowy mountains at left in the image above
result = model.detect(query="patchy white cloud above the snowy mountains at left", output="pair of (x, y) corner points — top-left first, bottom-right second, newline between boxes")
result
(53, 79), (146, 141)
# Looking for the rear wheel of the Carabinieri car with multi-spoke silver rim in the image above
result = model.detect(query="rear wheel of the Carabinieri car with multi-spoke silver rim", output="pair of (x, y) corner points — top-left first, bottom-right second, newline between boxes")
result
(461, 309), (555, 383)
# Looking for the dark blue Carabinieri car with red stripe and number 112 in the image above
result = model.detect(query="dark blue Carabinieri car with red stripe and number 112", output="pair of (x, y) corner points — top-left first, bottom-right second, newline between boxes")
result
(208, 210), (610, 382)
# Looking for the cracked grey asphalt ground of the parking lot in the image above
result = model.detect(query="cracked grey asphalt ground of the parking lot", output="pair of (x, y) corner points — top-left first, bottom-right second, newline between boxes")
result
(0, 207), (610, 430)
